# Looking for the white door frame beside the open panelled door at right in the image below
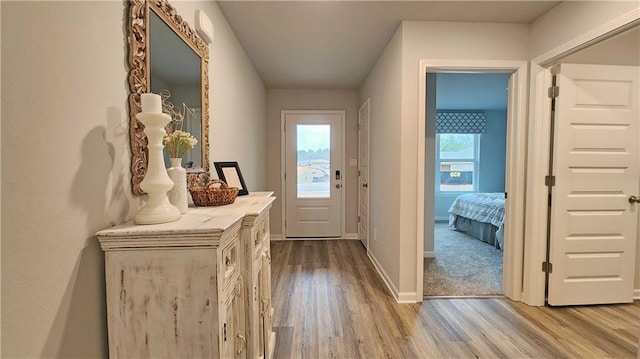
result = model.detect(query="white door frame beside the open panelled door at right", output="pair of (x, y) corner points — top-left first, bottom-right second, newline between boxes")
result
(522, 10), (640, 306)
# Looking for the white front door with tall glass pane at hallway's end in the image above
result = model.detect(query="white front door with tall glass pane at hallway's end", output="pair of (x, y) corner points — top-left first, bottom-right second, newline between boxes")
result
(283, 110), (346, 237)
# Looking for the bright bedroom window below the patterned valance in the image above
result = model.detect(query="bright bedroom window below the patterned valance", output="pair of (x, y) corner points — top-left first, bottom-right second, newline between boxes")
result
(435, 133), (480, 192)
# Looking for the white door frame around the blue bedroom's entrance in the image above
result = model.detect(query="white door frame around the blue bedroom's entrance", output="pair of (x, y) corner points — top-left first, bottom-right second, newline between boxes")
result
(416, 60), (528, 302)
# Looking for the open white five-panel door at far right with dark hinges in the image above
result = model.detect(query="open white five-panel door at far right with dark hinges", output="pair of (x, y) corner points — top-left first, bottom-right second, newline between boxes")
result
(548, 64), (640, 305)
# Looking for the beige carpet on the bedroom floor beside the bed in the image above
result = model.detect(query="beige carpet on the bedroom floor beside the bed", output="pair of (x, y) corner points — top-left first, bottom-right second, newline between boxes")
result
(424, 223), (502, 296)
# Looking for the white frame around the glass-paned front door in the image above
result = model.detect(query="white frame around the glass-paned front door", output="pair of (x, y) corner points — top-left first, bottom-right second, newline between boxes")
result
(280, 110), (347, 240)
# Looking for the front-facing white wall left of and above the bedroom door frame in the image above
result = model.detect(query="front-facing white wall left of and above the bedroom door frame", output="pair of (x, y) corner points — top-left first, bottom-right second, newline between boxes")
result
(399, 21), (528, 292)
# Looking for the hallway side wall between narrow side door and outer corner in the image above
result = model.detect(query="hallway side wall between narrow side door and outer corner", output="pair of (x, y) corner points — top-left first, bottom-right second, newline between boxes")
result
(360, 26), (402, 295)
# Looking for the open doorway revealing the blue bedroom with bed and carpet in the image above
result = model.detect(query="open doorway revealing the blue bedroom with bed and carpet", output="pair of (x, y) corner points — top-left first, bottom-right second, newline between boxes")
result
(423, 72), (510, 297)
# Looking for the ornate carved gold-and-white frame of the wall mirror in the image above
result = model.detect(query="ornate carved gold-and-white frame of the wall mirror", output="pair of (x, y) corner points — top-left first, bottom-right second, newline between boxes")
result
(128, 0), (209, 195)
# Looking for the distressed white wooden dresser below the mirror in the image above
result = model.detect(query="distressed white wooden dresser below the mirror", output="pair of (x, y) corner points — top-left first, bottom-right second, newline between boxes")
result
(96, 192), (275, 358)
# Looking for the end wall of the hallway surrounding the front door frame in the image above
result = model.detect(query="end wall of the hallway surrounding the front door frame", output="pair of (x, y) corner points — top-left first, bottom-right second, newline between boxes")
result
(266, 89), (359, 236)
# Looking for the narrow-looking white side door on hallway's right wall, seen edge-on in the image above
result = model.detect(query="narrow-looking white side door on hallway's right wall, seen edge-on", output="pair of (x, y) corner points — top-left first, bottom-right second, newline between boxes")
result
(358, 99), (370, 248)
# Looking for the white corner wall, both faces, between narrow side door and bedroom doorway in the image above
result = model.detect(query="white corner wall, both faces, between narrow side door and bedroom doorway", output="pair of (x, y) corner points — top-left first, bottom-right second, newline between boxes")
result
(361, 21), (529, 296)
